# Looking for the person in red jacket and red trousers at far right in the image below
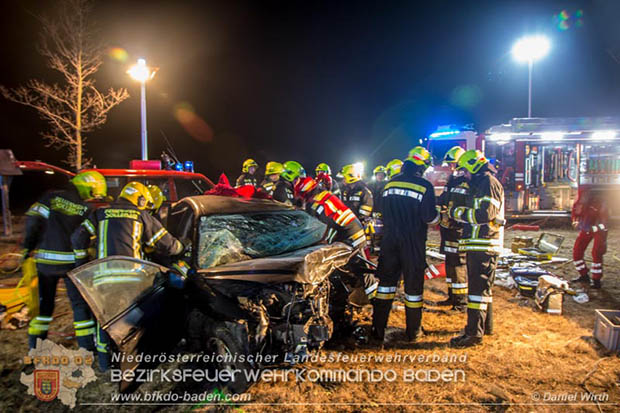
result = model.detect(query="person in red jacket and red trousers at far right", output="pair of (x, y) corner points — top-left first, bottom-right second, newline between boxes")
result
(572, 191), (609, 289)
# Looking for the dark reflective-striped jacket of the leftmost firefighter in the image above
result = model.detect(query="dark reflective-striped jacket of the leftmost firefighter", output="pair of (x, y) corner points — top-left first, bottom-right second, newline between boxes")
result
(23, 187), (91, 274)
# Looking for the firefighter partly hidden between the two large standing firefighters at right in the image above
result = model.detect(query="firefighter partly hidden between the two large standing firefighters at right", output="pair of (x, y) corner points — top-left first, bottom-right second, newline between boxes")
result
(437, 146), (469, 312)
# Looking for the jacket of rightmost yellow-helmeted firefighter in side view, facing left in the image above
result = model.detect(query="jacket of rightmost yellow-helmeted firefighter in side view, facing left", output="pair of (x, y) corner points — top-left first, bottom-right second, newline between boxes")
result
(450, 171), (505, 254)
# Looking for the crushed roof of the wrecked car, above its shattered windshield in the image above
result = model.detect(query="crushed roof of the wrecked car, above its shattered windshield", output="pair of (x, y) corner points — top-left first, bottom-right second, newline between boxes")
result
(173, 195), (294, 216)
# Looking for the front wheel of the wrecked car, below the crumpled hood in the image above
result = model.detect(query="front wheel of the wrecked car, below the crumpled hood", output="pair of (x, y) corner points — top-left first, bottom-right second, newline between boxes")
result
(206, 324), (252, 393)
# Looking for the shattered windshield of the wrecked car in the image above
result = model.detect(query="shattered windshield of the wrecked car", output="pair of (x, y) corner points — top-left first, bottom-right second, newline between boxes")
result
(198, 211), (325, 268)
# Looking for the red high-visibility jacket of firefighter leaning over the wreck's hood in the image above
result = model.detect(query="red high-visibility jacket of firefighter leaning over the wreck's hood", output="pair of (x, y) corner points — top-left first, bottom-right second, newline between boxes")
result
(306, 191), (366, 248)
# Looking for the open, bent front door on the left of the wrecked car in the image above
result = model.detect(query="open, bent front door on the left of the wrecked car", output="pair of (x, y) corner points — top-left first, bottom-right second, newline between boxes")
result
(69, 256), (184, 391)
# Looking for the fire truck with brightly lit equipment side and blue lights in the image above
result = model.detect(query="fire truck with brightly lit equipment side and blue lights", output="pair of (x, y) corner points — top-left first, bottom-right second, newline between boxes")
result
(429, 117), (620, 218)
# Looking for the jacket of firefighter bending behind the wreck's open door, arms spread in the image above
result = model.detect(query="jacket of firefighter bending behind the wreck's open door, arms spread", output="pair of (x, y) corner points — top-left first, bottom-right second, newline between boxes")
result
(71, 199), (183, 265)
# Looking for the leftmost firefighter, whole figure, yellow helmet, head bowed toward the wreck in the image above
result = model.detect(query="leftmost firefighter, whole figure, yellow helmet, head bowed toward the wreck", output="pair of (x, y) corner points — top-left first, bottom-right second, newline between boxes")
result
(23, 171), (107, 350)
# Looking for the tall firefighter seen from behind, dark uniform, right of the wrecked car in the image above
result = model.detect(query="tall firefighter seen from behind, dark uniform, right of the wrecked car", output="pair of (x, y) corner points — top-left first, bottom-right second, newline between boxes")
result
(371, 147), (439, 346)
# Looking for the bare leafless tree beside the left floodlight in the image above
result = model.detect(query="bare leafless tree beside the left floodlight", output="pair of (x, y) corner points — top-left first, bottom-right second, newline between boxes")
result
(0, 0), (129, 170)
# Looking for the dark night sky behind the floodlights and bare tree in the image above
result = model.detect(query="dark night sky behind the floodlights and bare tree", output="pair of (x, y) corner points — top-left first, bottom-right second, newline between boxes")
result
(0, 0), (620, 179)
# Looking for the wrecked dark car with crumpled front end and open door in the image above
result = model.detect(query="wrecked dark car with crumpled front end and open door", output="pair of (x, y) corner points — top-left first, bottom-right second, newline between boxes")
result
(69, 195), (364, 390)
